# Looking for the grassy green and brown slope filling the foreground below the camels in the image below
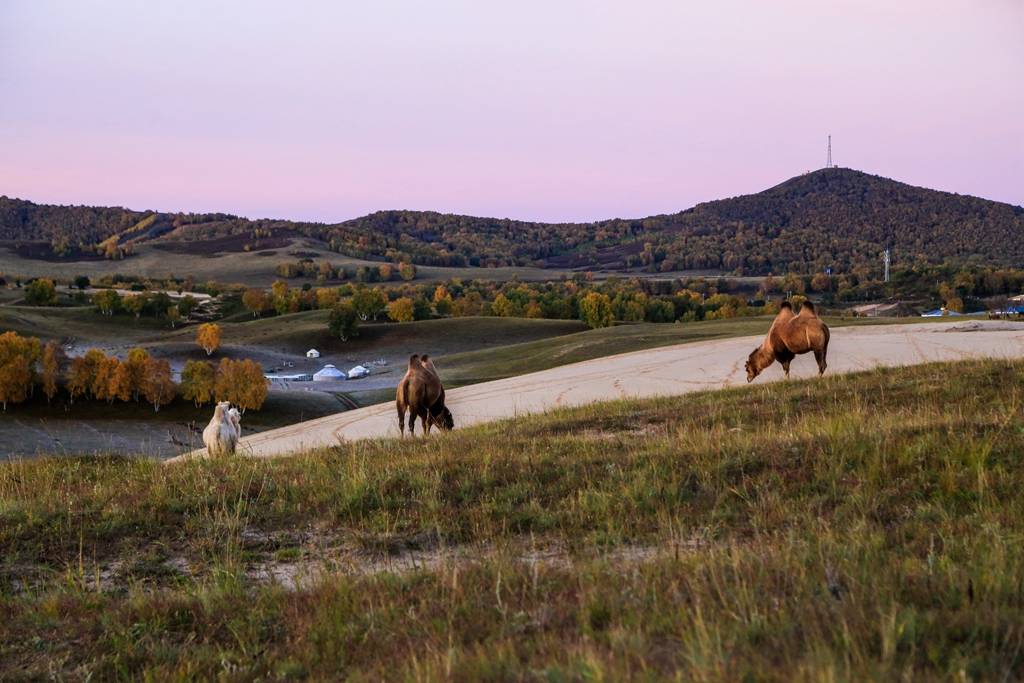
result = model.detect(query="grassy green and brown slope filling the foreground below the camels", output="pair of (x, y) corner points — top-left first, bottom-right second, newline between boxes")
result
(0, 361), (1024, 681)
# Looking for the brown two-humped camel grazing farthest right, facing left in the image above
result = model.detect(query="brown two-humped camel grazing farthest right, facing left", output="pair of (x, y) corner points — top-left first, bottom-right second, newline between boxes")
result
(746, 301), (828, 382)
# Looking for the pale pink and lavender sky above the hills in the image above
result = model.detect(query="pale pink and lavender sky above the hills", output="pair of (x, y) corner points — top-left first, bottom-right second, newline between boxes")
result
(0, 0), (1024, 221)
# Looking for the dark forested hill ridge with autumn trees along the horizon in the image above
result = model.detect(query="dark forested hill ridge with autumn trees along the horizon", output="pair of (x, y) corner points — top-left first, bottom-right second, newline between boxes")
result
(0, 169), (1024, 274)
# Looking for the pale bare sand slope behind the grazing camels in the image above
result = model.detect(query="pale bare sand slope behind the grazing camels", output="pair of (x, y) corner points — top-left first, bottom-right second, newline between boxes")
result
(172, 321), (1024, 458)
